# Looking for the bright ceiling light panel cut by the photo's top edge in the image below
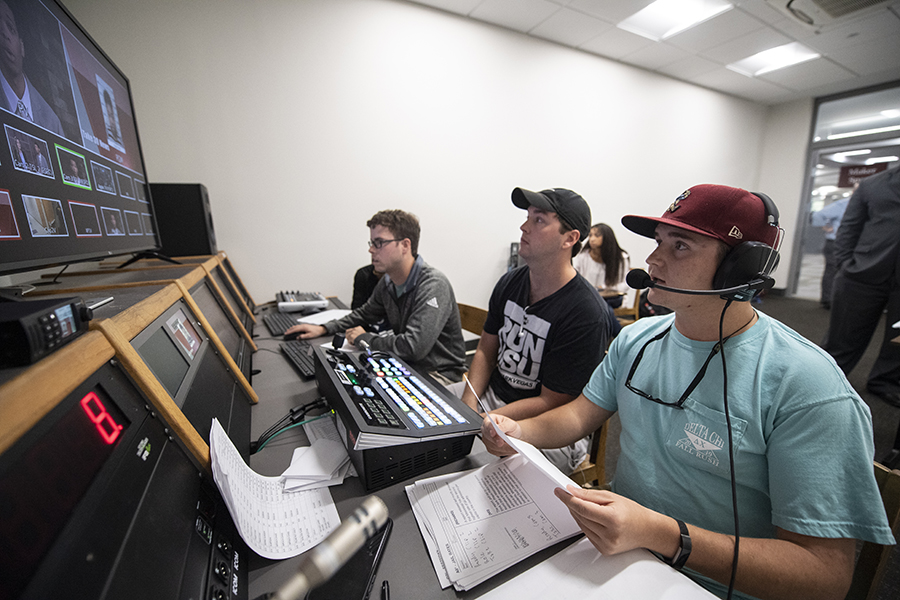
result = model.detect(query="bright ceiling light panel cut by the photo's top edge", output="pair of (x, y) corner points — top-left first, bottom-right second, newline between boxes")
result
(616, 0), (733, 42)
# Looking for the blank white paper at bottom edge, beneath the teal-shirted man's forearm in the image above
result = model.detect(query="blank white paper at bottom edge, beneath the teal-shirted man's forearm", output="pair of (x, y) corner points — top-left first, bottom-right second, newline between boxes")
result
(480, 538), (716, 600)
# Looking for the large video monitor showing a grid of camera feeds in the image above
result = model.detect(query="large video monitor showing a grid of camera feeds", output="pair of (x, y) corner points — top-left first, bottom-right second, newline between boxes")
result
(0, 0), (159, 275)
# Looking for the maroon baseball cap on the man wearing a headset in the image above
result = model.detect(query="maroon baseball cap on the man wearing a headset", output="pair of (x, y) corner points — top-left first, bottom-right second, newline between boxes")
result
(622, 184), (778, 247)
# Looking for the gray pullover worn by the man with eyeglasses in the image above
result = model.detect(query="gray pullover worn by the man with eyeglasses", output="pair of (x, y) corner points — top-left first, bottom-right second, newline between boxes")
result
(324, 255), (466, 381)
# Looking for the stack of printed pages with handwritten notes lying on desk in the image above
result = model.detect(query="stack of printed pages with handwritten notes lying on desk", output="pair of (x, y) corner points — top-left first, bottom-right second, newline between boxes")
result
(406, 455), (580, 590)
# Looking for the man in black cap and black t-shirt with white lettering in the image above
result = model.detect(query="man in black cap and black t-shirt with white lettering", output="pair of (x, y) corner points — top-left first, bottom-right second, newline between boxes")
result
(457, 188), (610, 473)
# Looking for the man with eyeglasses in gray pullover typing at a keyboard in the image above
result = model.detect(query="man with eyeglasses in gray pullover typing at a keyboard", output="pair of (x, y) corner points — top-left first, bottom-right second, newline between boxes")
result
(285, 210), (466, 383)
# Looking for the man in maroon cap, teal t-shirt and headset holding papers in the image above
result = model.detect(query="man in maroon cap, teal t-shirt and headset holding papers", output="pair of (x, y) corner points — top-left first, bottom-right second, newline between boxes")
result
(482, 185), (894, 600)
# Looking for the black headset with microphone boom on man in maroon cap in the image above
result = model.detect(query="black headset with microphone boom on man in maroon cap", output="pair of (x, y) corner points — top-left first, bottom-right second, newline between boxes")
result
(625, 192), (782, 302)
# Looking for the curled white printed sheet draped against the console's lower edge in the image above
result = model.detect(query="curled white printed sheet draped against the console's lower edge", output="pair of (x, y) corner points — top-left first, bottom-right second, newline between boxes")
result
(209, 419), (341, 559)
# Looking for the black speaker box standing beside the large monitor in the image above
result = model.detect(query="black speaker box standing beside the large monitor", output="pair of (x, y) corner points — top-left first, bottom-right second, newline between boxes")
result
(150, 183), (219, 256)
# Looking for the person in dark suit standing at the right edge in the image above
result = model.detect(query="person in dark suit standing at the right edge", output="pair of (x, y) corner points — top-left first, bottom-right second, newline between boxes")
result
(823, 168), (900, 407)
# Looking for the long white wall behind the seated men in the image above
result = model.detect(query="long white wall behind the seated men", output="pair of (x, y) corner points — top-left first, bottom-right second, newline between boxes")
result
(66, 0), (809, 306)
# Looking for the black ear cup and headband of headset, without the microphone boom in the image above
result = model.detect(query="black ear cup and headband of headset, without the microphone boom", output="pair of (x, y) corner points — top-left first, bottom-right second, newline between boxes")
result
(713, 192), (780, 301)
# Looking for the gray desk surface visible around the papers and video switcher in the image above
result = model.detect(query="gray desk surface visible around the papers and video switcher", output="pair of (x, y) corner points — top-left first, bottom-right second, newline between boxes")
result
(249, 304), (712, 600)
